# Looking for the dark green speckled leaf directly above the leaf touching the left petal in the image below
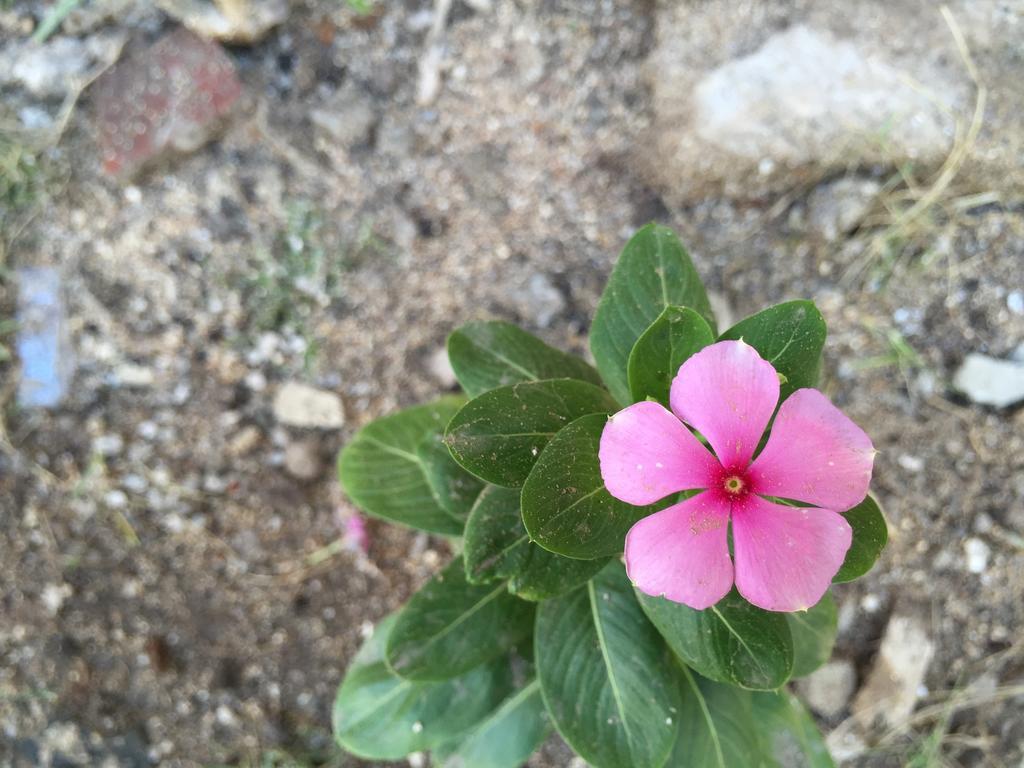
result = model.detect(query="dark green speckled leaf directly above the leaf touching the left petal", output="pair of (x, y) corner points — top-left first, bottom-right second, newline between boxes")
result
(445, 379), (616, 487)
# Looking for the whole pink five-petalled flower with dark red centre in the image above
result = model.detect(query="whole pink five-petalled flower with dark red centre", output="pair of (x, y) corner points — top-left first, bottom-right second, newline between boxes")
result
(600, 341), (876, 611)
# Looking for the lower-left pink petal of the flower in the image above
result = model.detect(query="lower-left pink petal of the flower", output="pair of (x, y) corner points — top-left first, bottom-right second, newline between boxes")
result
(626, 493), (732, 610)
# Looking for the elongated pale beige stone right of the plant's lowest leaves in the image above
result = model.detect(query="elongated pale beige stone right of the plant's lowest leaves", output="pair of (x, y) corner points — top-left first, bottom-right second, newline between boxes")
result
(853, 615), (935, 729)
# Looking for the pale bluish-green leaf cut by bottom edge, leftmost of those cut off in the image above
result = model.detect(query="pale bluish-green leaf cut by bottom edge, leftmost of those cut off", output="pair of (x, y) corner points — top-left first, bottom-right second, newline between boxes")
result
(434, 680), (551, 768)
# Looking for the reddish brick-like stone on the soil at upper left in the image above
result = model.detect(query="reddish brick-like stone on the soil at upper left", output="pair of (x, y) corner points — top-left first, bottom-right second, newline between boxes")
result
(96, 29), (242, 177)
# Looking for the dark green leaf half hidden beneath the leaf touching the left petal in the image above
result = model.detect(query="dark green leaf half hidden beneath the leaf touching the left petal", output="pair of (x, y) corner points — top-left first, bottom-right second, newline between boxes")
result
(463, 485), (607, 600)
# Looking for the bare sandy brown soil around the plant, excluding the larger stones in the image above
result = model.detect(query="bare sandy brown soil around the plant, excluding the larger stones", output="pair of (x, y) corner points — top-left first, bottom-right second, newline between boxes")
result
(0, 0), (1024, 766)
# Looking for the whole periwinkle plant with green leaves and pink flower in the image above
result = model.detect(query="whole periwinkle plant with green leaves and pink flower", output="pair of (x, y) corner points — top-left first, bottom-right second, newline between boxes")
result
(333, 225), (886, 768)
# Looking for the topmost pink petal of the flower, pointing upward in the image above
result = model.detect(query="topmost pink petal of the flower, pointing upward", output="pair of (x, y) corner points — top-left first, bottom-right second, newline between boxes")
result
(669, 341), (778, 469)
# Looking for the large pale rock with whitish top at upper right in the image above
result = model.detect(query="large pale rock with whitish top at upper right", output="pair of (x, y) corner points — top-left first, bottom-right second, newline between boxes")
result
(645, 20), (967, 201)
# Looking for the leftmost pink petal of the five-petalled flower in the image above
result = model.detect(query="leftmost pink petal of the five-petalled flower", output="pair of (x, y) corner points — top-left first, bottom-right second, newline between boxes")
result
(598, 402), (718, 505)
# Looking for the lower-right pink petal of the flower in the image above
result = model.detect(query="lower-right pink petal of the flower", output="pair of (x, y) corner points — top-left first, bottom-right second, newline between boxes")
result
(732, 494), (853, 611)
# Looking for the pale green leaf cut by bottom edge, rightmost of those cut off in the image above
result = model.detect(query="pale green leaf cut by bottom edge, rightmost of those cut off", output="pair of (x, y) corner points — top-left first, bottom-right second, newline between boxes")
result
(751, 690), (835, 768)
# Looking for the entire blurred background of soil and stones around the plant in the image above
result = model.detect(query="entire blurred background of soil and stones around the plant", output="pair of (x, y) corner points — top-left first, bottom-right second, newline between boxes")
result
(0, 0), (1024, 766)
